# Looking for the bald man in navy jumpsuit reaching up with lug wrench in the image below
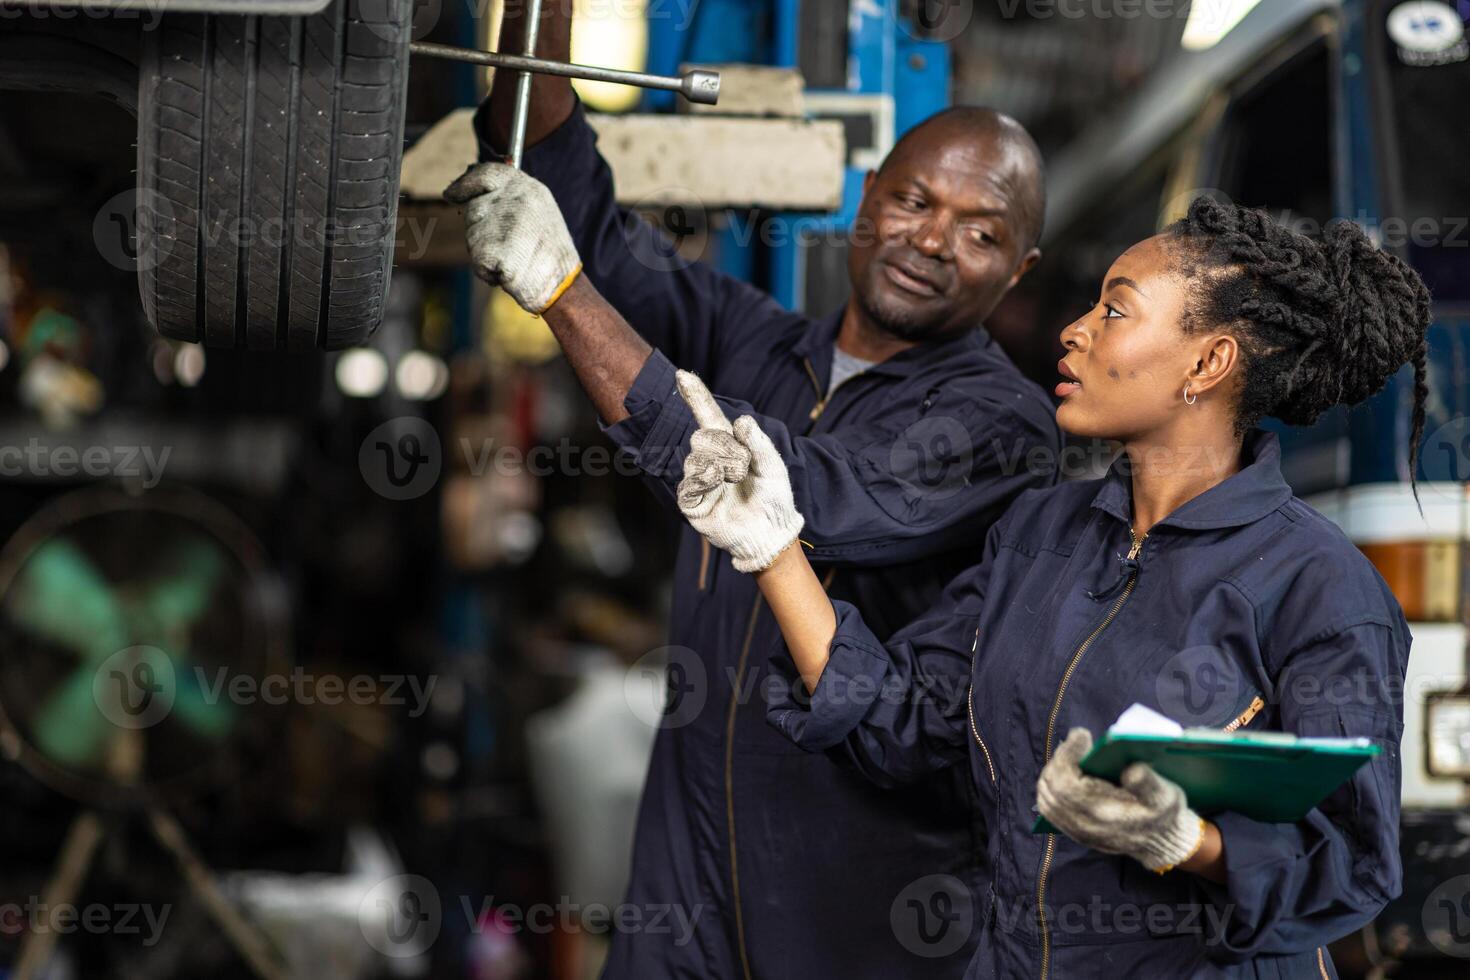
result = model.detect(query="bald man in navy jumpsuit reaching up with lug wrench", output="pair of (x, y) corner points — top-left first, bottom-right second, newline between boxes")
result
(445, 3), (1060, 980)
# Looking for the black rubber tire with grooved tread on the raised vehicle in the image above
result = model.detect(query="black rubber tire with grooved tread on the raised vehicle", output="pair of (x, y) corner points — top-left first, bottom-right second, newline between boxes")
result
(137, 0), (413, 350)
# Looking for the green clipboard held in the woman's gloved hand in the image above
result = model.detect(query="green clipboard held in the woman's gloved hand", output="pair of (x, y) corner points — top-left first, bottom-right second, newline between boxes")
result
(1030, 729), (1380, 833)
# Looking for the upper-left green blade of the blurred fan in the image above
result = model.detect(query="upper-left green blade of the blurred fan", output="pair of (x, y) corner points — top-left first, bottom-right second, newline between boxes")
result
(7, 539), (126, 664)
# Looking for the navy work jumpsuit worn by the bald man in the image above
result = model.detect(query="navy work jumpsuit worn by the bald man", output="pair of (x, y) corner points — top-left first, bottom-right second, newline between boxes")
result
(478, 107), (1058, 980)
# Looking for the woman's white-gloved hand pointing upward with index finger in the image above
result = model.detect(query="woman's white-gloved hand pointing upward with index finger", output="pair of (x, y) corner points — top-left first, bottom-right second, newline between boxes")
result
(676, 370), (803, 572)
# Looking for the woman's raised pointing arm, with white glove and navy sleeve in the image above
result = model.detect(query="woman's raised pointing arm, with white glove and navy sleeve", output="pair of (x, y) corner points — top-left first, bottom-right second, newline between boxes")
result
(678, 399), (998, 786)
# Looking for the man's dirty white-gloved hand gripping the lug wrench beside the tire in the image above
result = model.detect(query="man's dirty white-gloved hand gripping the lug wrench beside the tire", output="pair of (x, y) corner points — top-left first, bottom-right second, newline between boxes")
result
(444, 163), (582, 314)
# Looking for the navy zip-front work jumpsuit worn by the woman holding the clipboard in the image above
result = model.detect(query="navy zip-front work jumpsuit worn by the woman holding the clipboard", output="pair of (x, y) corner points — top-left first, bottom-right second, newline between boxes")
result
(770, 430), (1410, 980)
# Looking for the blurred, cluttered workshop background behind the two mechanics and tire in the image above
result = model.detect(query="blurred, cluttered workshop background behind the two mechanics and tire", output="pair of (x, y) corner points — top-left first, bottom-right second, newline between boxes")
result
(0, 0), (1470, 980)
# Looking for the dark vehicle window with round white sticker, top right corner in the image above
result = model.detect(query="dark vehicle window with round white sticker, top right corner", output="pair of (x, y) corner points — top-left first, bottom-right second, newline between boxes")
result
(1372, 3), (1470, 303)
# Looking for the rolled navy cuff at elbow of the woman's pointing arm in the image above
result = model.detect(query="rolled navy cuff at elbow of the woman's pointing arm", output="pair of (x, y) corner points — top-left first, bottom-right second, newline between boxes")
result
(766, 601), (889, 752)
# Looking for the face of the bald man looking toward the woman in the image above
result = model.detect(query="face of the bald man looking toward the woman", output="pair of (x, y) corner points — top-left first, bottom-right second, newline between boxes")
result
(847, 132), (1039, 341)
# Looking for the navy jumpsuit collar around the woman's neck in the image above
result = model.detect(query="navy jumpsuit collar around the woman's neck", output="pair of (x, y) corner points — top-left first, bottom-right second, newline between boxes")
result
(1092, 429), (1291, 530)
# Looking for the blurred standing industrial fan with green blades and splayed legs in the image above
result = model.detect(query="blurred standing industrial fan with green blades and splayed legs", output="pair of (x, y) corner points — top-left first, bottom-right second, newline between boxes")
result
(0, 489), (292, 980)
